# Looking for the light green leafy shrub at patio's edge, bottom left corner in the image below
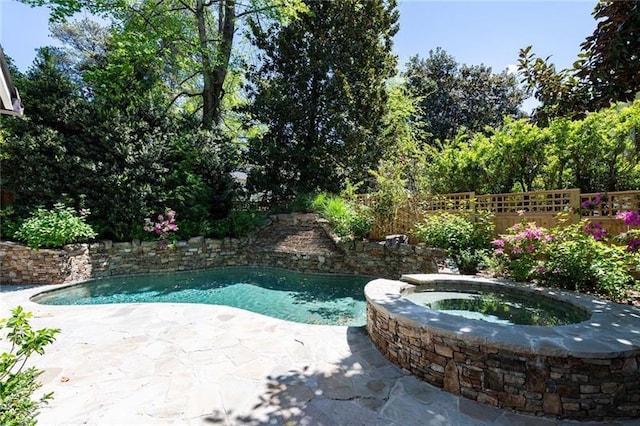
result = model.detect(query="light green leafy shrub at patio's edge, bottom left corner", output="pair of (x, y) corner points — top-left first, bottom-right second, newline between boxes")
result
(0, 306), (60, 426)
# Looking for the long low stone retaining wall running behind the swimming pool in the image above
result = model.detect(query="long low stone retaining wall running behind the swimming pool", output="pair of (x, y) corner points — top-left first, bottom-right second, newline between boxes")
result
(0, 215), (442, 284)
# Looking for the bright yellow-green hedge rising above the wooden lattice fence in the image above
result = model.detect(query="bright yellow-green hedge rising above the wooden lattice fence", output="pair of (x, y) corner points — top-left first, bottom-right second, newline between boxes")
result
(425, 100), (640, 193)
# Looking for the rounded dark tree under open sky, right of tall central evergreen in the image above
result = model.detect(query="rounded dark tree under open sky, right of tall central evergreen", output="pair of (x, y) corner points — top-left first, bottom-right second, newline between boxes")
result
(404, 48), (525, 143)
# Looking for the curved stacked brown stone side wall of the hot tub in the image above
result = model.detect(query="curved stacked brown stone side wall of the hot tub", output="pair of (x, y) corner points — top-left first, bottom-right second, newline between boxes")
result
(367, 302), (640, 420)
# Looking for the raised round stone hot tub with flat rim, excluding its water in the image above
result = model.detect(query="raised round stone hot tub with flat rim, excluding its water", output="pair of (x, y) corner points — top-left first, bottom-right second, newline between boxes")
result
(365, 274), (640, 420)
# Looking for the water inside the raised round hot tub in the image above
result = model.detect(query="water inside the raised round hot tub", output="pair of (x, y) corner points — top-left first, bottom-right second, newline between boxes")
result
(405, 290), (589, 326)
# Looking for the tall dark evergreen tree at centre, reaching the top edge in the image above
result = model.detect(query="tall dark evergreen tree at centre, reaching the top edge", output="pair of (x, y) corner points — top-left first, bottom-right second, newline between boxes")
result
(247, 0), (398, 200)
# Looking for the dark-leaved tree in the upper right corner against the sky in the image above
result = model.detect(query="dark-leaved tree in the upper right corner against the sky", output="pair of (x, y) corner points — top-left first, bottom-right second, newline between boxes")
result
(518, 1), (640, 125)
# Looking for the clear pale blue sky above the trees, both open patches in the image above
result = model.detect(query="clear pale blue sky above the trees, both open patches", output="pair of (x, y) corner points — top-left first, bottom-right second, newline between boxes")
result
(0, 0), (596, 72)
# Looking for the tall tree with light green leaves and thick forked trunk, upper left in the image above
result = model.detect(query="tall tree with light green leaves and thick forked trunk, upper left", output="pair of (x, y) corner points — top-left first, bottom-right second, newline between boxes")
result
(21, 0), (304, 129)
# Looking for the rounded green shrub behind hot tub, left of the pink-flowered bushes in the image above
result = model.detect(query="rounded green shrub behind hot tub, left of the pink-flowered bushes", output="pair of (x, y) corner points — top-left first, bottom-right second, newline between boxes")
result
(415, 212), (494, 274)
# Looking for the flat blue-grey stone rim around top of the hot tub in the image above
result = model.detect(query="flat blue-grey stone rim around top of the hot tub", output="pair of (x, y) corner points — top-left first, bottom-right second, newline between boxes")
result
(365, 274), (640, 359)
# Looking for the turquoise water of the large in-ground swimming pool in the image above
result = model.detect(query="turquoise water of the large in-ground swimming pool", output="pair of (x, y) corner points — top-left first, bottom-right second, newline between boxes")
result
(33, 268), (370, 326)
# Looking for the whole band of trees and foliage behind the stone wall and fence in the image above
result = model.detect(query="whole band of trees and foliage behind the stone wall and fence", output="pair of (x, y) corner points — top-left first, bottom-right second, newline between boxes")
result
(0, 0), (640, 245)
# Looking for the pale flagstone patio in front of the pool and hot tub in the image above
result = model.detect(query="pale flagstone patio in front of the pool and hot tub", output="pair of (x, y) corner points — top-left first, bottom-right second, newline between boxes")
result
(0, 286), (640, 426)
